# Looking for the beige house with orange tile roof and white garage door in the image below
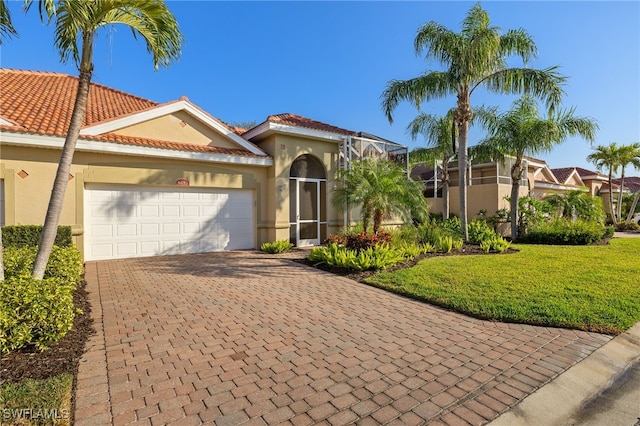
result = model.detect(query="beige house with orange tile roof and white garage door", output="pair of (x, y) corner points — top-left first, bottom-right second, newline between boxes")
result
(0, 69), (407, 260)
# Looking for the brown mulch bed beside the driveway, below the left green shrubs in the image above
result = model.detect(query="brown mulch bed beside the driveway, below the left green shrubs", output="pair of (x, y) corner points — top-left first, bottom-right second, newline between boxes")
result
(0, 283), (94, 384)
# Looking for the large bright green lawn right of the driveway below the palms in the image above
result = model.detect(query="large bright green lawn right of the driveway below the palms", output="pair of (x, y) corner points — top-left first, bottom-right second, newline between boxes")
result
(365, 238), (640, 334)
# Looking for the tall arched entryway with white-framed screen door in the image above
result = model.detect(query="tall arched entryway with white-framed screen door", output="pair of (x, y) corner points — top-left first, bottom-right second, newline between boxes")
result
(289, 154), (327, 247)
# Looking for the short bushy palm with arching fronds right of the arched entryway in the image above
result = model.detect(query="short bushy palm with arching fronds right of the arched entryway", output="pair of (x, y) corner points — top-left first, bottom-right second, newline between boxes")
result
(333, 159), (428, 233)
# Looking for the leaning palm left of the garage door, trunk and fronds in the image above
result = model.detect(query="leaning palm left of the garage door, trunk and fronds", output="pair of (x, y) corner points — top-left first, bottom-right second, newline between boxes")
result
(32, 0), (183, 279)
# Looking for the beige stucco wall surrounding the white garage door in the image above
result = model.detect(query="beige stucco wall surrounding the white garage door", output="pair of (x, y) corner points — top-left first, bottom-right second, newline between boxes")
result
(0, 145), (269, 258)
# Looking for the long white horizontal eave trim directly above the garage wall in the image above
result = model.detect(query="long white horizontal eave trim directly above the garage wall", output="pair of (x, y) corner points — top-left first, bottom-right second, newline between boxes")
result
(0, 131), (273, 166)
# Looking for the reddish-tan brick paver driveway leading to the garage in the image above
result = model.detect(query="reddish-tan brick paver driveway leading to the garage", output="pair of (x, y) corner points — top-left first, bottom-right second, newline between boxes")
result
(75, 252), (610, 425)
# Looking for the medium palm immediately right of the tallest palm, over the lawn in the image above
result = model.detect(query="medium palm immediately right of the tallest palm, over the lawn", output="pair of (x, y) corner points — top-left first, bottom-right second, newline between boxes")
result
(478, 96), (598, 241)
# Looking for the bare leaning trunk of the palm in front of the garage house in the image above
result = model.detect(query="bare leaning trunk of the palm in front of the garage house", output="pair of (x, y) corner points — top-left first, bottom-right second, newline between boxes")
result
(31, 32), (93, 280)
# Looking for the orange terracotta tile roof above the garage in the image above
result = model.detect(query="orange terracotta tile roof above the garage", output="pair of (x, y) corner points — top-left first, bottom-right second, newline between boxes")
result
(0, 69), (264, 157)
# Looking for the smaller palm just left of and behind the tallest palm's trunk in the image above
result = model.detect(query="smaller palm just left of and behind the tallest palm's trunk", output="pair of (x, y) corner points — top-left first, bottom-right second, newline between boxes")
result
(407, 110), (458, 219)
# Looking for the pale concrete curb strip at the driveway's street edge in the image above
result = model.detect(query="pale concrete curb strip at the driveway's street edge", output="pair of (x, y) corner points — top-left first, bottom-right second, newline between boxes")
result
(489, 322), (640, 426)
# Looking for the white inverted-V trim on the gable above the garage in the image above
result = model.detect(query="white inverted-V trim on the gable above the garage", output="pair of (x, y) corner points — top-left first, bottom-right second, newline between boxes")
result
(80, 100), (266, 155)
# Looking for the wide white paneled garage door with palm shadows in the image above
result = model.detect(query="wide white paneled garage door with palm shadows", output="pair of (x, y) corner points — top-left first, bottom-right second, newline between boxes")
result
(84, 185), (255, 260)
